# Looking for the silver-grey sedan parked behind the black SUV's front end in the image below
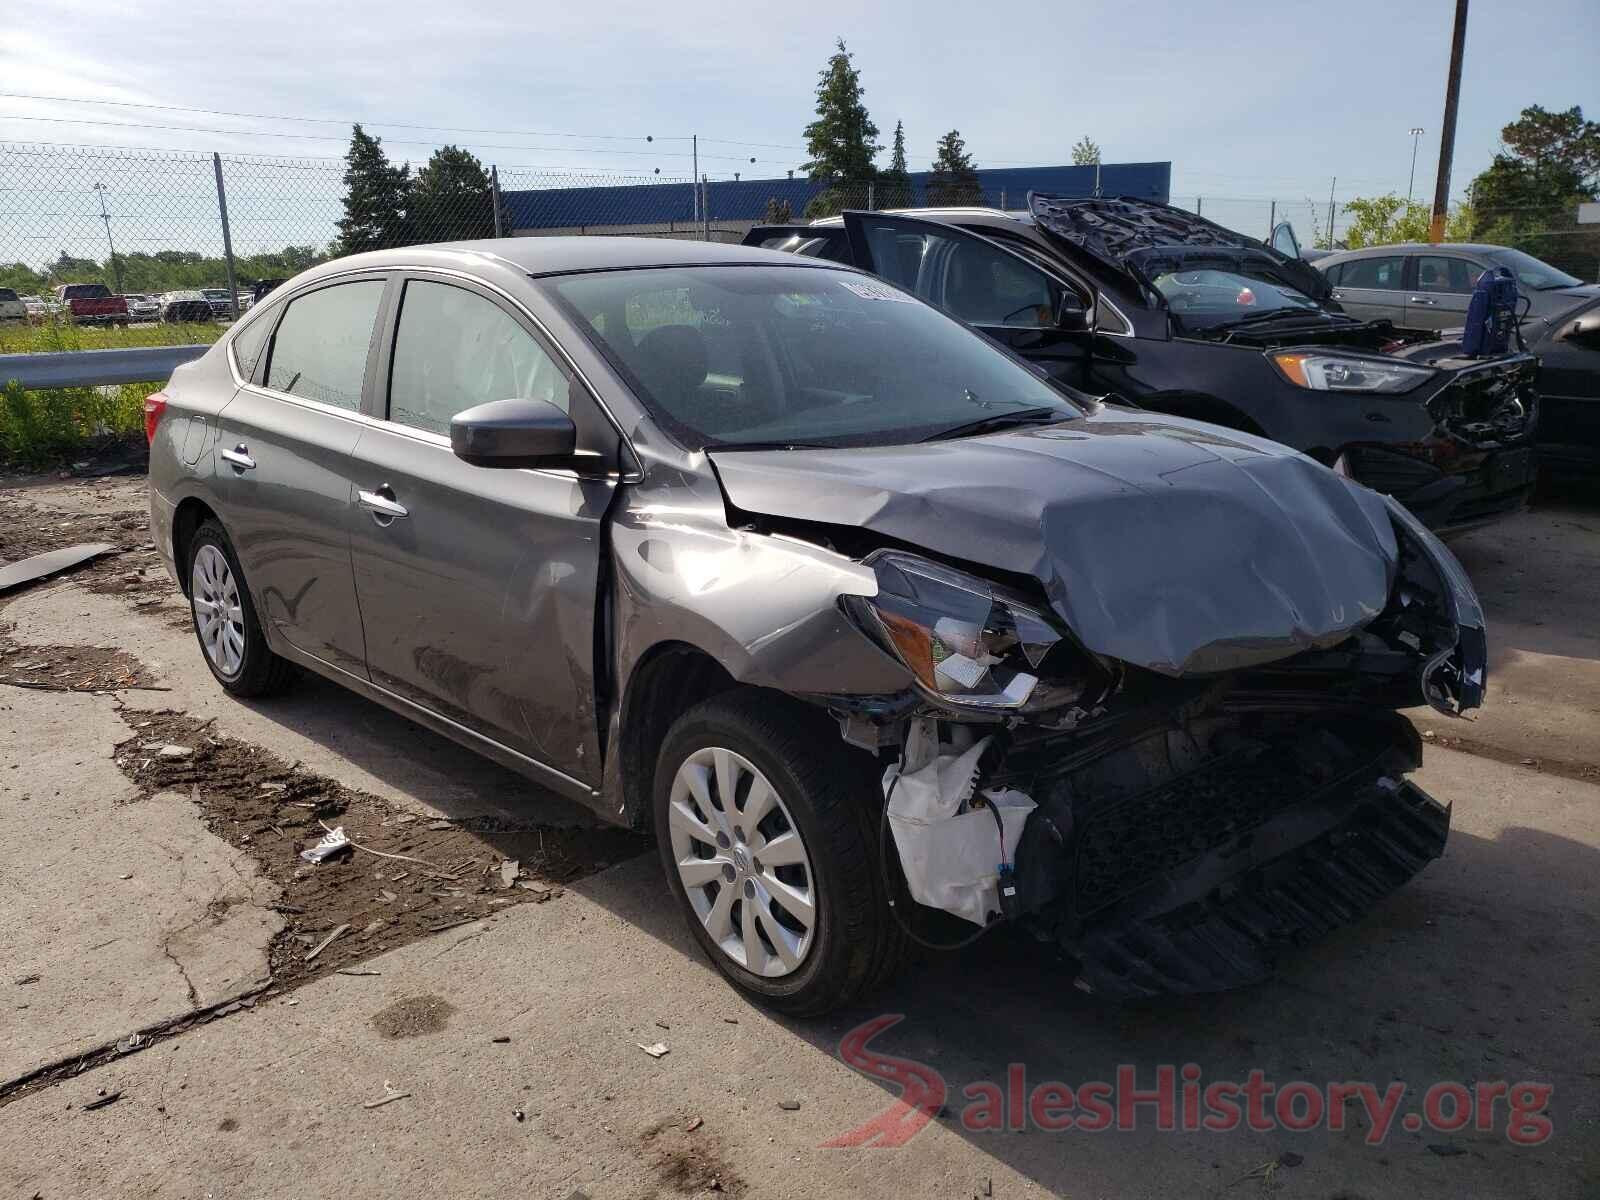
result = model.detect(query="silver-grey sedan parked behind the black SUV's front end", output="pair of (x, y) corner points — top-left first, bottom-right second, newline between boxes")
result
(1315, 242), (1600, 333)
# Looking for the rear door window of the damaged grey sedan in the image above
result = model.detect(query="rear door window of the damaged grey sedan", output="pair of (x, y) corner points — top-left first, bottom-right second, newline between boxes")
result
(265, 280), (384, 411)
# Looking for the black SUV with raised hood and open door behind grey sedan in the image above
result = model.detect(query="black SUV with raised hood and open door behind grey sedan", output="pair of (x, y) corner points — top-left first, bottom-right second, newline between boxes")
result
(746, 194), (1539, 531)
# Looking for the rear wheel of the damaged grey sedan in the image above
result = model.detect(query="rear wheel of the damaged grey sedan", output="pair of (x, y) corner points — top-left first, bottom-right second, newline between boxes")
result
(187, 520), (296, 698)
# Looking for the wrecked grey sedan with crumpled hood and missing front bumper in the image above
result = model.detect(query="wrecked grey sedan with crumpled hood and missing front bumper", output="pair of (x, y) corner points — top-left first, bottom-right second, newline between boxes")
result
(146, 238), (1485, 1013)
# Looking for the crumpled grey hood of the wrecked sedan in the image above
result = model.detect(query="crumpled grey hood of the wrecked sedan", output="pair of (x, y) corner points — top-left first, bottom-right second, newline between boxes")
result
(710, 408), (1398, 675)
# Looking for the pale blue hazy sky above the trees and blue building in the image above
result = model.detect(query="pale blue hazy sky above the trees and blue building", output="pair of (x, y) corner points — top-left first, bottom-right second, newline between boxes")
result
(0, 0), (1600, 241)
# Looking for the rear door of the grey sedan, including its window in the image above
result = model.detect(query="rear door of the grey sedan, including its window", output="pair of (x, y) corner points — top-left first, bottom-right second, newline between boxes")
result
(216, 275), (386, 677)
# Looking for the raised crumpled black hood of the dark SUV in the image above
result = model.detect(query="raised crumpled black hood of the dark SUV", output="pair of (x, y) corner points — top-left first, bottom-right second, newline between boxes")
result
(1027, 192), (1333, 301)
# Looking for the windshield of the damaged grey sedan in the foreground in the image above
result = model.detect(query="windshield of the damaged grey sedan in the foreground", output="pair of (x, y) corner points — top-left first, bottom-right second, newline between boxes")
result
(552, 266), (1082, 450)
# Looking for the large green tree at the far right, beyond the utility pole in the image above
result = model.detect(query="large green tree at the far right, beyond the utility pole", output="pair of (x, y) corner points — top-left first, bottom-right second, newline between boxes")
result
(1470, 104), (1600, 278)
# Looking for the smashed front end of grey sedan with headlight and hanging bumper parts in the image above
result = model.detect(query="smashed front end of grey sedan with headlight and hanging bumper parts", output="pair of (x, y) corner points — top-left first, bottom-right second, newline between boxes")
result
(830, 502), (1485, 998)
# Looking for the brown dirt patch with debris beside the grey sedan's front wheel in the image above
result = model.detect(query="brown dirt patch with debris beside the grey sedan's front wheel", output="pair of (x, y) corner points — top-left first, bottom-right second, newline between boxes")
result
(115, 709), (646, 989)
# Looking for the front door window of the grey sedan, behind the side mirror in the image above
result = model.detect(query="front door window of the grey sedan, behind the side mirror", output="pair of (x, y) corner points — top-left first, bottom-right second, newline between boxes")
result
(389, 280), (568, 435)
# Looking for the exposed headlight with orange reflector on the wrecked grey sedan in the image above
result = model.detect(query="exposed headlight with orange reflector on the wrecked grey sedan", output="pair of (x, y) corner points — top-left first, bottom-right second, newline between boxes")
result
(843, 550), (1090, 712)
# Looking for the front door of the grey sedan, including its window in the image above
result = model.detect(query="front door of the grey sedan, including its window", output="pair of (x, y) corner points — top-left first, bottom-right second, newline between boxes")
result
(349, 275), (616, 786)
